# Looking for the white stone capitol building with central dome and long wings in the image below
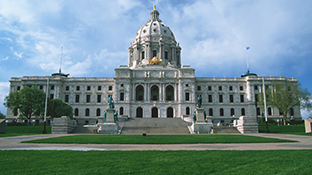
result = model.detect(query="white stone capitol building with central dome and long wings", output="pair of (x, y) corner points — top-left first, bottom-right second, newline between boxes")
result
(6, 7), (301, 124)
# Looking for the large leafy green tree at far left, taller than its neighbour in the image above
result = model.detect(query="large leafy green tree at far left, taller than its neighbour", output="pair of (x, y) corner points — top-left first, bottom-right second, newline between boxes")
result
(4, 86), (46, 124)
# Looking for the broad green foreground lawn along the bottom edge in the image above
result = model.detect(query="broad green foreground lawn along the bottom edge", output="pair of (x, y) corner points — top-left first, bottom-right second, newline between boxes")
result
(0, 150), (312, 175)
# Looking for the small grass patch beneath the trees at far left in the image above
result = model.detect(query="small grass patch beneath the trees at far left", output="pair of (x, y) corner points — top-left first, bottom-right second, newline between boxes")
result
(0, 126), (51, 137)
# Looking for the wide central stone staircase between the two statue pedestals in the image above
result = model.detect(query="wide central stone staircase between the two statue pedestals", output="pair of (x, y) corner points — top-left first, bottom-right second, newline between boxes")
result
(119, 118), (191, 134)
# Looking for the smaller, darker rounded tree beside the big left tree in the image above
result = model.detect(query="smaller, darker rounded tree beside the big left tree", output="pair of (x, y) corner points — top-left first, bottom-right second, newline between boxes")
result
(47, 98), (73, 118)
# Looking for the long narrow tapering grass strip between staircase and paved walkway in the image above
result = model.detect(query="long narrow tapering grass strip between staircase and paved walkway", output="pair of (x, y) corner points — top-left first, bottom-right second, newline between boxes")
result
(23, 135), (292, 144)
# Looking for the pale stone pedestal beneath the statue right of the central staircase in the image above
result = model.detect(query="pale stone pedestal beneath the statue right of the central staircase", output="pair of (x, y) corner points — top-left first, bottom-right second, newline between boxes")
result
(192, 108), (212, 134)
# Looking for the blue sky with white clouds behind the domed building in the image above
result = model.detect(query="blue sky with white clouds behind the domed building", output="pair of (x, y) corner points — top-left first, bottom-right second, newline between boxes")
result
(0, 0), (312, 118)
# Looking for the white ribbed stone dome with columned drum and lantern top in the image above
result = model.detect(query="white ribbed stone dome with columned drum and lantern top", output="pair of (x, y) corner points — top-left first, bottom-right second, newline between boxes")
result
(128, 5), (181, 68)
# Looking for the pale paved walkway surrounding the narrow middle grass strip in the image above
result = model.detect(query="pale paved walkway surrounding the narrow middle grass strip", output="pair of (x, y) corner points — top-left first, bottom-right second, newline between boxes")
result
(0, 134), (312, 151)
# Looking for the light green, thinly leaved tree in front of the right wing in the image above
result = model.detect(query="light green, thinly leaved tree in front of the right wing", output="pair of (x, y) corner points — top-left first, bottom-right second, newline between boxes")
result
(258, 81), (312, 125)
